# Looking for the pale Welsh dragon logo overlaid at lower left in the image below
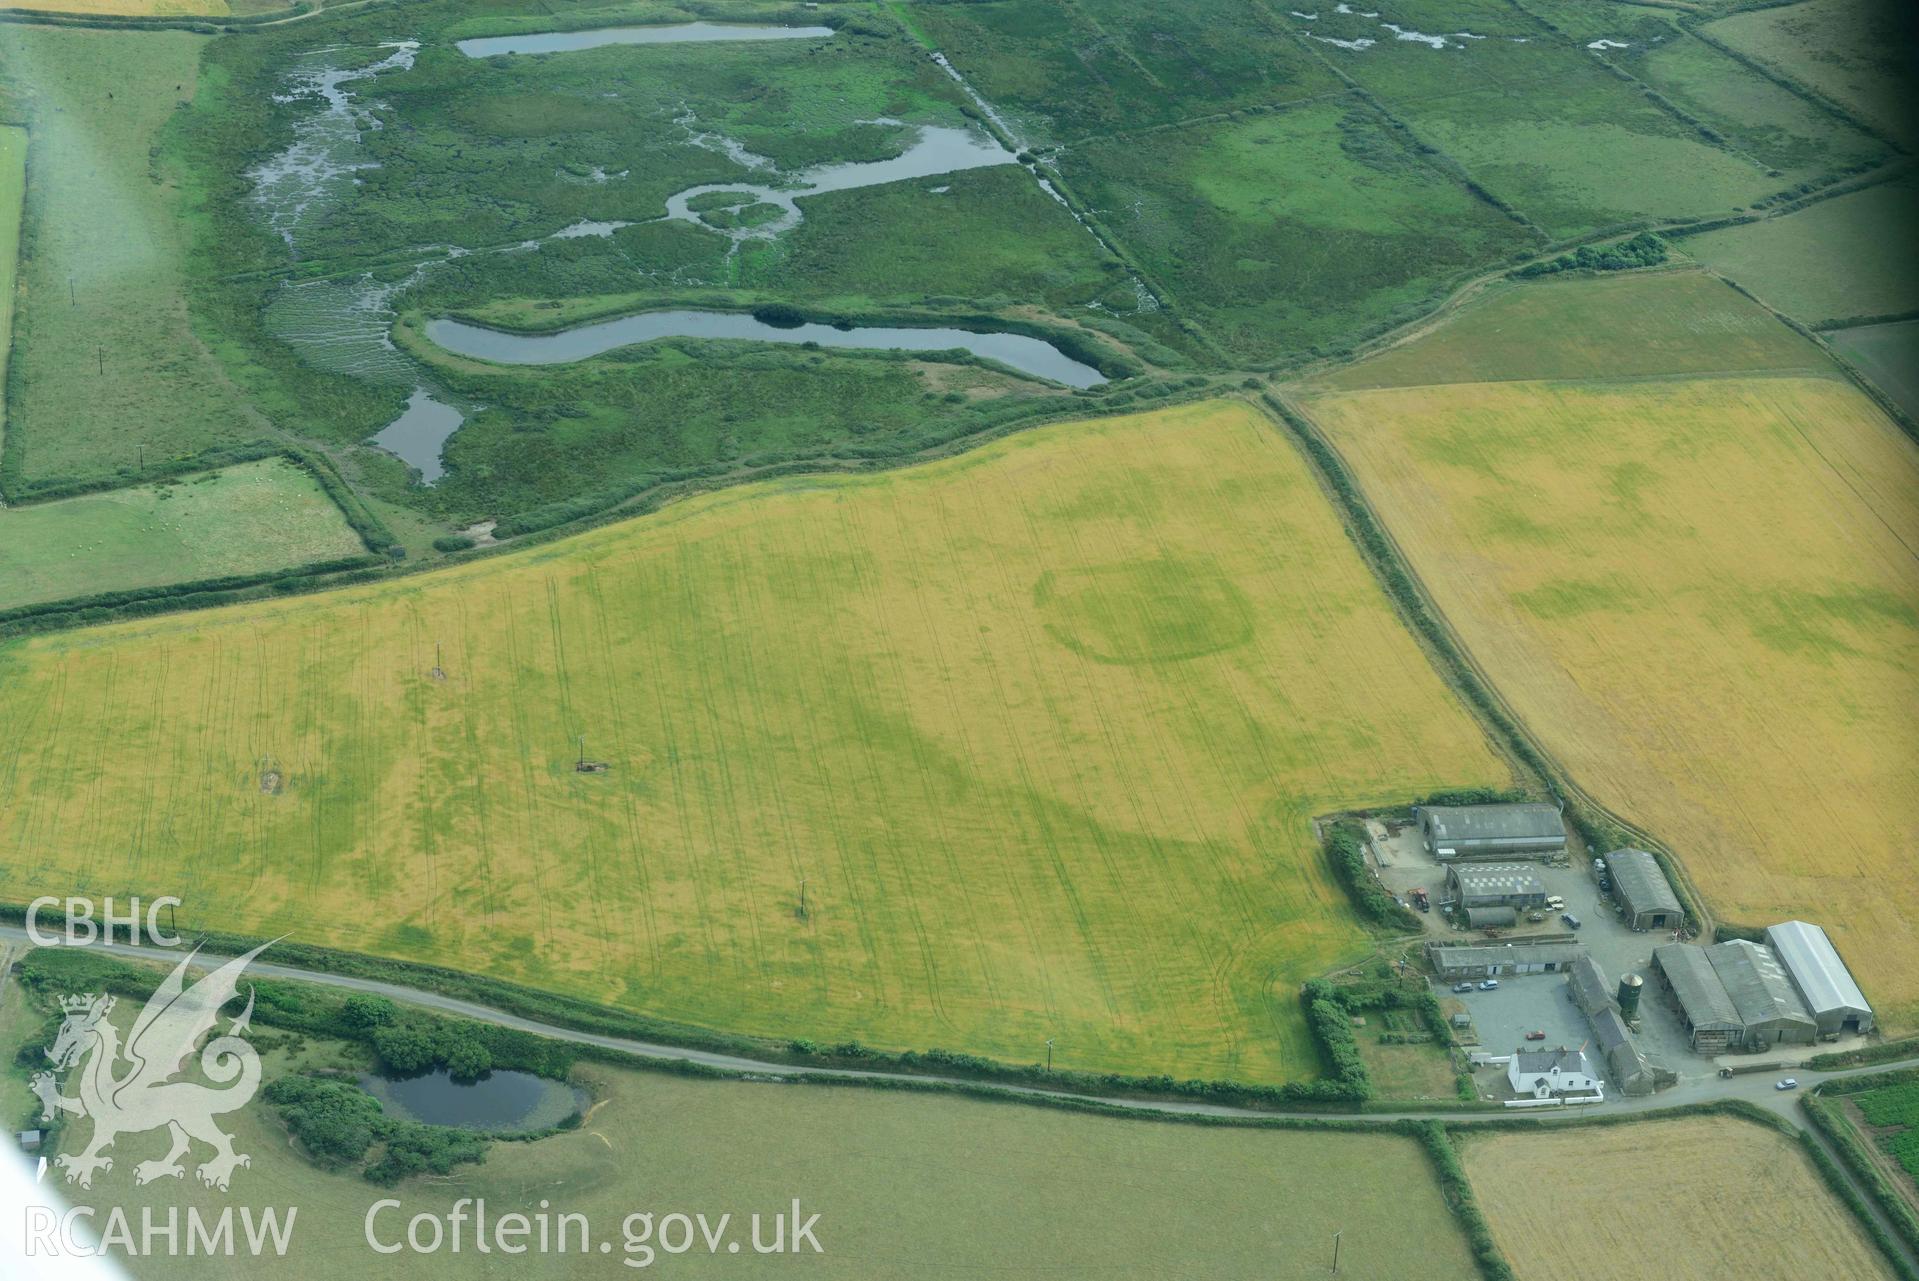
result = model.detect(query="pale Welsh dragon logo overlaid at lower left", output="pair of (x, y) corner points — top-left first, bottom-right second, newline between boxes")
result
(33, 943), (269, 1191)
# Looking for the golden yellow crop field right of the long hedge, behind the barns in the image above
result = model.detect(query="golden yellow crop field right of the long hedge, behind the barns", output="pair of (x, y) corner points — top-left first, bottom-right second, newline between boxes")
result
(1311, 376), (1919, 1028)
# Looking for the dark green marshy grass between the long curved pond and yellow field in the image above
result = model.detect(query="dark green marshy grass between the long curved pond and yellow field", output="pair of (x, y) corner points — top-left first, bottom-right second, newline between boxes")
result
(389, 324), (1071, 525)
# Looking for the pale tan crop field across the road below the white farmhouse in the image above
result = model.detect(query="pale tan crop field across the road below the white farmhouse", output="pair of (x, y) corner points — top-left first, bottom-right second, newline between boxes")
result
(1460, 1116), (1894, 1281)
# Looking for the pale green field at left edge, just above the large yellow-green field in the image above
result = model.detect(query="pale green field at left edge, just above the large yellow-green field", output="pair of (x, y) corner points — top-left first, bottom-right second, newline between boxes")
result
(0, 458), (367, 610)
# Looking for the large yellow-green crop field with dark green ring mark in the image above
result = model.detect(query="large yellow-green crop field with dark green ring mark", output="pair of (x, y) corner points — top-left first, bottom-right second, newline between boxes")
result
(0, 403), (1508, 1082)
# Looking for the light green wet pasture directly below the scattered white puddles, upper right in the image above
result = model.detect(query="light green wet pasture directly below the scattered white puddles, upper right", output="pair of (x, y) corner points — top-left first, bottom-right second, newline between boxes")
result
(1313, 36), (1787, 238)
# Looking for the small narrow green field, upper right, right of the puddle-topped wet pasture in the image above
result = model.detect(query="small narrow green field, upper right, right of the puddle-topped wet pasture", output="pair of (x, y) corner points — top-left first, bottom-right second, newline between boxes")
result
(1608, 27), (1890, 184)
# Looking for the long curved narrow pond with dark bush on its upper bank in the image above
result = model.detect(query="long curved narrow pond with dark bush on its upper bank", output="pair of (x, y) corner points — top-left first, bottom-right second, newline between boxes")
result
(426, 311), (1105, 387)
